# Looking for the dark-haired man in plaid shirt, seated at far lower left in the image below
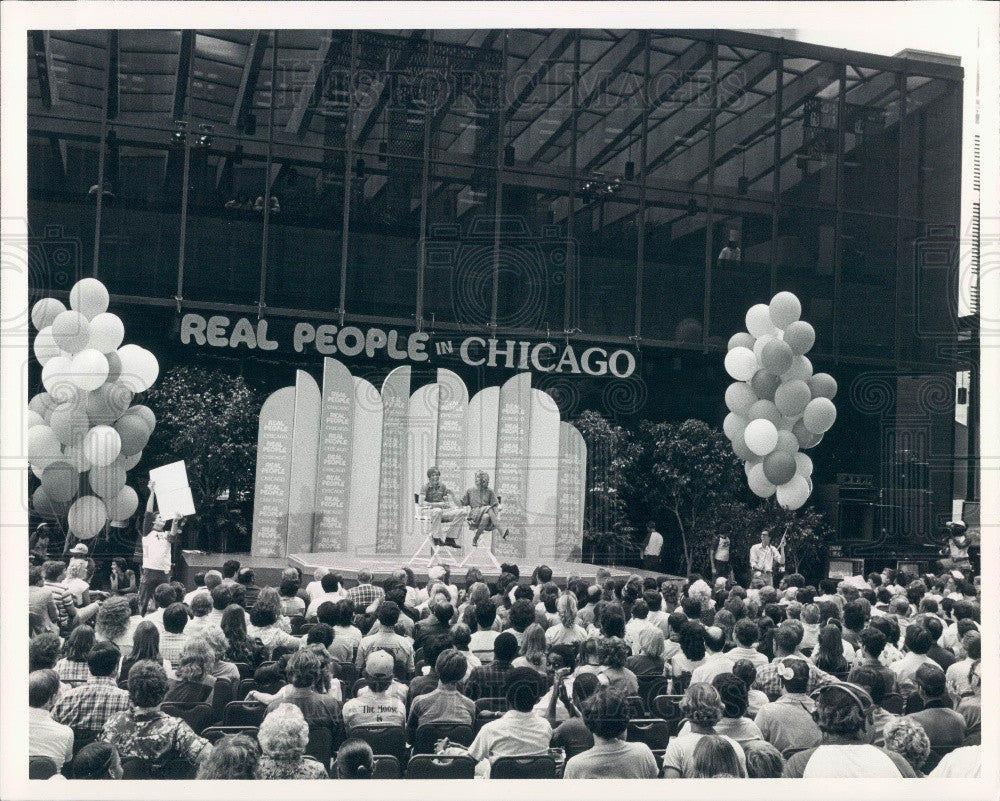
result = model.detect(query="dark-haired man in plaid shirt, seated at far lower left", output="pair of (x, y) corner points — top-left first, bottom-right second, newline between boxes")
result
(52, 642), (132, 742)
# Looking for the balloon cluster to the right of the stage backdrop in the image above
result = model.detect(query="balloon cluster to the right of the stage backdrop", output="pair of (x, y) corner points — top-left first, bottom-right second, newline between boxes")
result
(722, 292), (837, 509)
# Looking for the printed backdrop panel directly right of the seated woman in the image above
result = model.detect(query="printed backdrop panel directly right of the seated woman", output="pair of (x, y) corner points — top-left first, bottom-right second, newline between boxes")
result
(493, 373), (531, 559)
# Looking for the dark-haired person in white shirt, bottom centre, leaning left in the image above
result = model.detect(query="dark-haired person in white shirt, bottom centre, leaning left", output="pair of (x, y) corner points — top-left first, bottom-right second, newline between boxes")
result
(469, 668), (552, 775)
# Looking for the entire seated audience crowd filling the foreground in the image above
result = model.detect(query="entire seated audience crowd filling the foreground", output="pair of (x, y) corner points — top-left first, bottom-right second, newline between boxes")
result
(28, 558), (981, 780)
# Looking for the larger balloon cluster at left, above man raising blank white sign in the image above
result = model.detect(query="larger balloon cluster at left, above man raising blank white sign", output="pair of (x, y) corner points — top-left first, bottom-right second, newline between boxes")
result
(27, 278), (160, 540)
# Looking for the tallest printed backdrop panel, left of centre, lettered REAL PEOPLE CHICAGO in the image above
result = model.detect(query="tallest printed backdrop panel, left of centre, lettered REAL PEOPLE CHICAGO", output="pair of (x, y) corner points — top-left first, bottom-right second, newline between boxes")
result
(312, 358), (354, 551)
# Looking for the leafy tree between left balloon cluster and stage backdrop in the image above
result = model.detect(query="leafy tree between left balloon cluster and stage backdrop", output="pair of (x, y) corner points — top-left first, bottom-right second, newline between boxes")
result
(146, 367), (261, 513)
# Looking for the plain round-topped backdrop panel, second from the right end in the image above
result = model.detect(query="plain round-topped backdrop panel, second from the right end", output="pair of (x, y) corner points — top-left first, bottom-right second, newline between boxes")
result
(525, 389), (559, 559)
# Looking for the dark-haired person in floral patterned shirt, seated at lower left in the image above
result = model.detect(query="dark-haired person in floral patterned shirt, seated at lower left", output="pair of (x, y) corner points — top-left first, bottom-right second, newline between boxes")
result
(100, 661), (212, 770)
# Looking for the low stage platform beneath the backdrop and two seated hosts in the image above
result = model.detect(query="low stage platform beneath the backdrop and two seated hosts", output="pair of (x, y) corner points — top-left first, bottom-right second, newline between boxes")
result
(183, 551), (684, 587)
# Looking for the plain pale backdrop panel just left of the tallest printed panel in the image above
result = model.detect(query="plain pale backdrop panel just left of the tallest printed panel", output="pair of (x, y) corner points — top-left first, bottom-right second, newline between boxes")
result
(286, 370), (320, 553)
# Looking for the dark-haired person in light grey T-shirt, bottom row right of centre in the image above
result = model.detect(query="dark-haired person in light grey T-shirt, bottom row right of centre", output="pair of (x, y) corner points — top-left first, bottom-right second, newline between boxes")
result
(563, 684), (662, 779)
